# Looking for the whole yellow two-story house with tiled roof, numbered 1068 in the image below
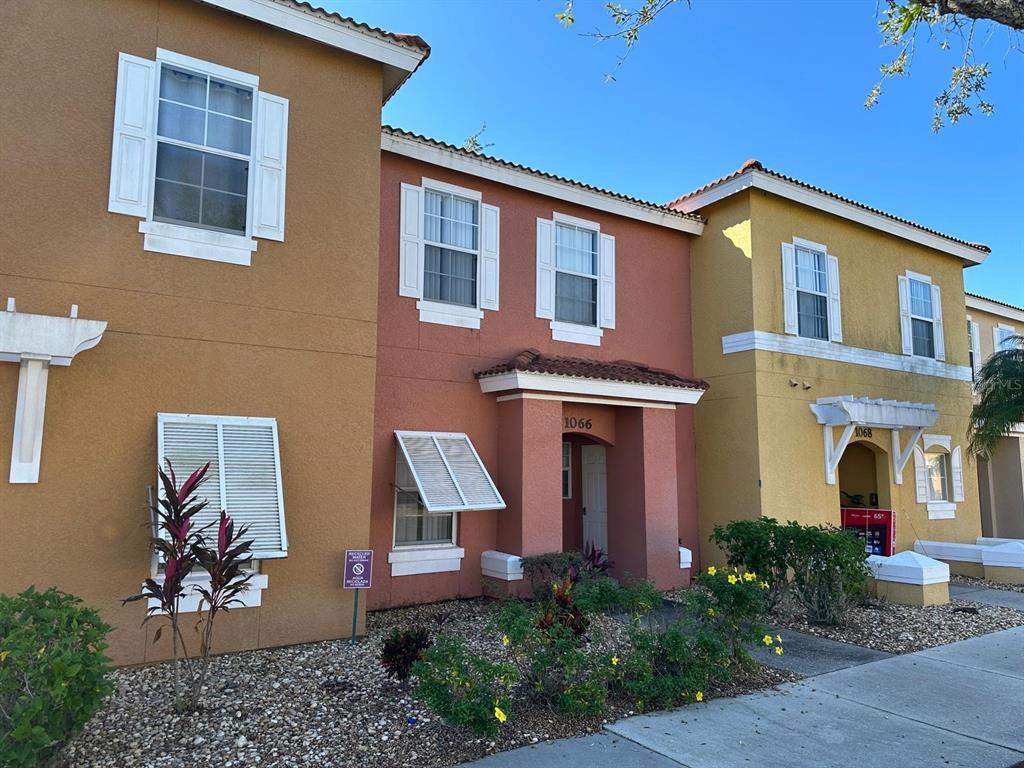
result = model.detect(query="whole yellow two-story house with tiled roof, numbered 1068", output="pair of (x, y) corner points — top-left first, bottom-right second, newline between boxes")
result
(671, 161), (988, 559)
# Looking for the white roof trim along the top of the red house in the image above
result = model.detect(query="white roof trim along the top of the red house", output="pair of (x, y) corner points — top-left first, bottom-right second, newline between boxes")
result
(381, 132), (703, 234)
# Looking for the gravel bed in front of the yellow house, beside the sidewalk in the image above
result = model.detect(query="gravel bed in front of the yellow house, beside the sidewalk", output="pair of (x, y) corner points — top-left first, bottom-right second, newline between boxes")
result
(770, 600), (1024, 653)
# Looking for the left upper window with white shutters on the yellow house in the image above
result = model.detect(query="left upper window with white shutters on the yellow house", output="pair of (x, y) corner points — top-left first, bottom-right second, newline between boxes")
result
(782, 238), (843, 341)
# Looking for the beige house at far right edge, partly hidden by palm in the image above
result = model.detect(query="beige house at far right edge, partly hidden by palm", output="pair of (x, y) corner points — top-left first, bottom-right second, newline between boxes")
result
(967, 294), (1024, 539)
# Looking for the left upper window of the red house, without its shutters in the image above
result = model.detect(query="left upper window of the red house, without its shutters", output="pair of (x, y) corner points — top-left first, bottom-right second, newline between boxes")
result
(423, 189), (479, 307)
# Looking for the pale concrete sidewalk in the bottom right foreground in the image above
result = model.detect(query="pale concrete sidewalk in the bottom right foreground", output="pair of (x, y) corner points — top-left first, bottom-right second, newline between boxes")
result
(474, 627), (1024, 768)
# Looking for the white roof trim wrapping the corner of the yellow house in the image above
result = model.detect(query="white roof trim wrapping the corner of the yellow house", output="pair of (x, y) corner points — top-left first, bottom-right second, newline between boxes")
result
(678, 169), (988, 264)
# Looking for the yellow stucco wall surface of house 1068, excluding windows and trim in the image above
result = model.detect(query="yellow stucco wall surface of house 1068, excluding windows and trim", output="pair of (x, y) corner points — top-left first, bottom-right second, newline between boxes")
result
(691, 189), (980, 559)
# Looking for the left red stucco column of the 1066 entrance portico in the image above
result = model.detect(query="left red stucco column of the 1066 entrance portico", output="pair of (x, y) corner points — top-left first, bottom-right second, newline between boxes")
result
(498, 398), (562, 555)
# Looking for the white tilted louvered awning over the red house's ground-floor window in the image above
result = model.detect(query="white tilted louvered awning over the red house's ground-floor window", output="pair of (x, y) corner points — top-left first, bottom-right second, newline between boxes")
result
(394, 431), (505, 512)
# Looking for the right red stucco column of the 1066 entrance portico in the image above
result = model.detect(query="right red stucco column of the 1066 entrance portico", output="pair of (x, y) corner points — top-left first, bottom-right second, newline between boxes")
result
(608, 408), (684, 589)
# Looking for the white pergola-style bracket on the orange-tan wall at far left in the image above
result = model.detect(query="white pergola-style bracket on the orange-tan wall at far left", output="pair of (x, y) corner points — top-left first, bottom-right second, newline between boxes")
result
(0, 298), (106, 482)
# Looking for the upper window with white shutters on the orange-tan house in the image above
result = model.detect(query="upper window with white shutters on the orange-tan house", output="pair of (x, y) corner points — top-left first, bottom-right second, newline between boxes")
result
(108, 48), (288, 264)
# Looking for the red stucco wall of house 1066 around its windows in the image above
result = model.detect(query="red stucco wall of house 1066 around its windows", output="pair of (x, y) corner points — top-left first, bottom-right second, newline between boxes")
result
(370, 152), (699, 607)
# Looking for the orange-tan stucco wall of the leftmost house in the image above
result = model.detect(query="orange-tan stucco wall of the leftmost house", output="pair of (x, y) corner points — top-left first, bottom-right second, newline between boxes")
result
(0, 0), (382, 663)
